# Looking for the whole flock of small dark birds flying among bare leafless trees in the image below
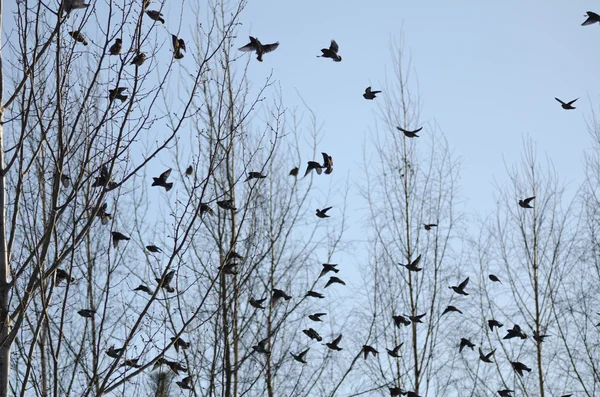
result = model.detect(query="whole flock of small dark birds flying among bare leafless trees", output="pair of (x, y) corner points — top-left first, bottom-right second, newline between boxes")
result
(56, 0), (600, 397)
